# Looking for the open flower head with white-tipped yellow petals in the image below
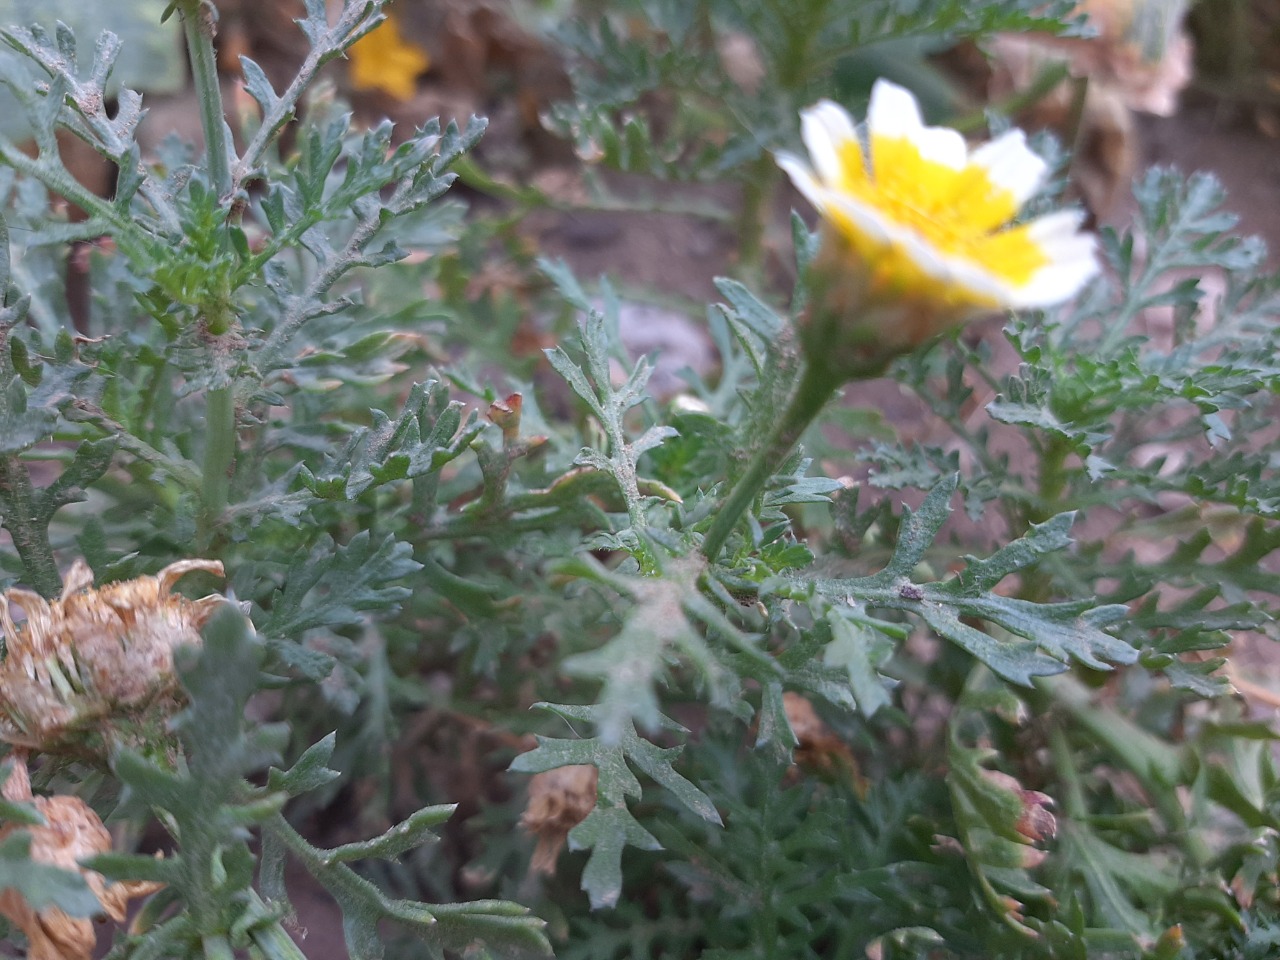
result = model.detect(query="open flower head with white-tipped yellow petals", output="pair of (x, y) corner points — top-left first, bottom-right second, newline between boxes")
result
(777, 79), (1098, 317)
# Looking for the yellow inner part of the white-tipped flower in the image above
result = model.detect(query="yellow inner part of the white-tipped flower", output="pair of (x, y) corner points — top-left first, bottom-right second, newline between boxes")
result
(827, 134), (1050, 306)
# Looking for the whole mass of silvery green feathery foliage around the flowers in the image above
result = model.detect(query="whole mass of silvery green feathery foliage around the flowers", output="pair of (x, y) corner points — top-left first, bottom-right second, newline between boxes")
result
(0, 0), (1280, 960)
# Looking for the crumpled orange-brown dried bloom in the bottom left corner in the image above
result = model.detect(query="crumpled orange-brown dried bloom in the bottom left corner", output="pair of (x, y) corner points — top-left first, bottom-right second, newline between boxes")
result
(0, 762), (160, 960)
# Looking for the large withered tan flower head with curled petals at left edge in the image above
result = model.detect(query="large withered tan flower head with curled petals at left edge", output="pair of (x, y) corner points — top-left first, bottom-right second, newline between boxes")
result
(0, 559), (223, 750)
